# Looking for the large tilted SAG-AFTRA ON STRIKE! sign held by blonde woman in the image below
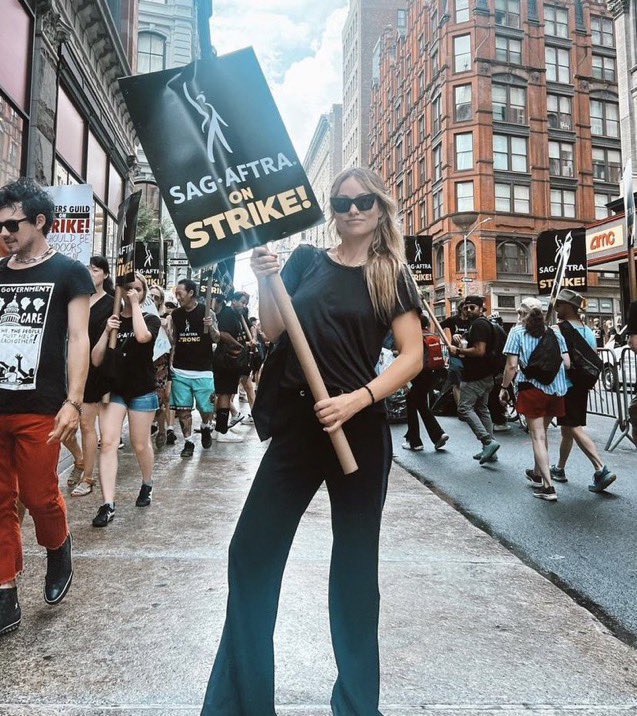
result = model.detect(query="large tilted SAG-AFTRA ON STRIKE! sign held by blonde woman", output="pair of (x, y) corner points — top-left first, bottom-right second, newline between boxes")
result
(120, 48), (324, 269)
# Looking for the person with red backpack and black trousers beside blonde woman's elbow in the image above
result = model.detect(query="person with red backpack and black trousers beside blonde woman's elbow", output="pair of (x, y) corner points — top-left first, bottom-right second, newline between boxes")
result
(403, 313), (449, 452)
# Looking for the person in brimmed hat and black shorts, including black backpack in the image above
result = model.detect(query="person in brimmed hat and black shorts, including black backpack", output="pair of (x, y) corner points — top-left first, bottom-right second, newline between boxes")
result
(551, 288), (617, 492)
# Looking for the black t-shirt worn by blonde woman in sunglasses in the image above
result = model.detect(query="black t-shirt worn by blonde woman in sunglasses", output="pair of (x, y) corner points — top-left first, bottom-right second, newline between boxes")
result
(281, 245), (421, 392)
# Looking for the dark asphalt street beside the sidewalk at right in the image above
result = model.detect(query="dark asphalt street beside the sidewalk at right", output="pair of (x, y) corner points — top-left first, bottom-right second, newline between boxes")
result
(393, 415), (637, 644)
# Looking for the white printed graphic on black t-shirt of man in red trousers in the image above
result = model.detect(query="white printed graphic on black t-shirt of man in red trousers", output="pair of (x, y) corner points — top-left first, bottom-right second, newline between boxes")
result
(0, 283), (54, 390)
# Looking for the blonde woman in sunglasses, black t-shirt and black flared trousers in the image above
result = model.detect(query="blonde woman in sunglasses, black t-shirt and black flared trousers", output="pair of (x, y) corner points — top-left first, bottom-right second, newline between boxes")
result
(202, 169), (423, 716)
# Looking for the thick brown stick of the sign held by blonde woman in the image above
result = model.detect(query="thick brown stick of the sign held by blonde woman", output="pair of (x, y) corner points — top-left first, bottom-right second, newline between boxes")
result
(268, 274), (358, 475)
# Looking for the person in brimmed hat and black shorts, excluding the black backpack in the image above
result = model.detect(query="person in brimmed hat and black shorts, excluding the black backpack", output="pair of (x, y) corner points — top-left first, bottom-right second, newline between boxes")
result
(551, 288), (617, 492)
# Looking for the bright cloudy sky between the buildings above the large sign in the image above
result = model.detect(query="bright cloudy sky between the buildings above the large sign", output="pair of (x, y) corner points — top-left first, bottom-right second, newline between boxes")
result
(211, 0), (348, 160)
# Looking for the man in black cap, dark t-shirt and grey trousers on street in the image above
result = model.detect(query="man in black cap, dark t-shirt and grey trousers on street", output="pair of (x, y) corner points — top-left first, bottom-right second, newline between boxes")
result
(449, 296), (500, 465)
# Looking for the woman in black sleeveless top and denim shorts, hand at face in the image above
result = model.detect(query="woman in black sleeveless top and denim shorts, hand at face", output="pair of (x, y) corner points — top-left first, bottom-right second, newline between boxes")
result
(91, 274), (161, 527)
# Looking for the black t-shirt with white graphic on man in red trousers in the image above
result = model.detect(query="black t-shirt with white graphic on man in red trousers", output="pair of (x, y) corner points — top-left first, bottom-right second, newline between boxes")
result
(0, 253), (95, 415)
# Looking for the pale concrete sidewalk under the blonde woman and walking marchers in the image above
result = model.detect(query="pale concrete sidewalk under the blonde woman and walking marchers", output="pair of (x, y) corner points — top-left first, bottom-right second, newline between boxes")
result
(0, 431), (637, 716)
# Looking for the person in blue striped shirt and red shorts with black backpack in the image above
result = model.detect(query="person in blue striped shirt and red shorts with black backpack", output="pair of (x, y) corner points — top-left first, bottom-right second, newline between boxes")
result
(500, 298), (570, 502)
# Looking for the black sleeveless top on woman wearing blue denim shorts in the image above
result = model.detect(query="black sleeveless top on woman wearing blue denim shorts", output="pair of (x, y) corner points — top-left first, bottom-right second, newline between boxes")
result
(110, 313), (161, 400)
